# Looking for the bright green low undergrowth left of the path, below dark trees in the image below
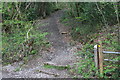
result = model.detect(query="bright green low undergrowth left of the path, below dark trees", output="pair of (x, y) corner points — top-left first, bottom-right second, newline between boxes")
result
(2, 21), (50, 64)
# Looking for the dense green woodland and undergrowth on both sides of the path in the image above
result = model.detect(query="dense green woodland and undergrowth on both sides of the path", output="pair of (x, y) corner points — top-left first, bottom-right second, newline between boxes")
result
(0, 2), (120, 78)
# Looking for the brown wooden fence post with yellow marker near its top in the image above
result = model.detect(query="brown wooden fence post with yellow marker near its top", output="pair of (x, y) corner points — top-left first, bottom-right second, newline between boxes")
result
(98, 43), (103, 76)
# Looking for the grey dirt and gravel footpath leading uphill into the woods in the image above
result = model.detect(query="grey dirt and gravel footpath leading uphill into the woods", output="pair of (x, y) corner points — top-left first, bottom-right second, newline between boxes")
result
(2, 10), (81, 78)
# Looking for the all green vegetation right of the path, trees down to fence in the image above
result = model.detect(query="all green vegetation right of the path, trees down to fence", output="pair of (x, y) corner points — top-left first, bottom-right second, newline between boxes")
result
(61, 2), (120, 78)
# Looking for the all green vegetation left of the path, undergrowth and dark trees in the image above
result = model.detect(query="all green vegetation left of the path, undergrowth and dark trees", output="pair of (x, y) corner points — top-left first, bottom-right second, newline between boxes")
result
(1, 2), (57, 64)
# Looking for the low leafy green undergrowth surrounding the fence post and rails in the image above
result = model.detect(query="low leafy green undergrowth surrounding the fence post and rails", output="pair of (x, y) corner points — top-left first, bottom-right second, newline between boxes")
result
(77, 27), (120, 78)
